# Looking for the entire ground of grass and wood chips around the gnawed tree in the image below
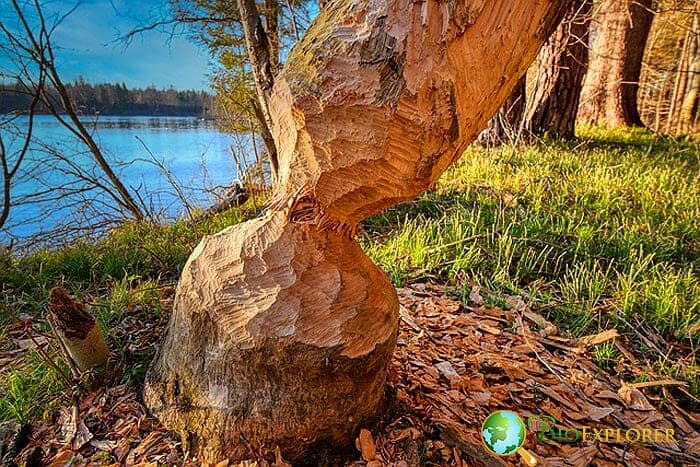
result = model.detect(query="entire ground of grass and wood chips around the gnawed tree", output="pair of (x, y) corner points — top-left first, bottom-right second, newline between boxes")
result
(0, 129), (700, 465)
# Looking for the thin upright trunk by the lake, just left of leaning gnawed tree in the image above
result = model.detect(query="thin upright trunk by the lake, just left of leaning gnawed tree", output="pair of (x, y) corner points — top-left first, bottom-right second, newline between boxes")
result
(237, 0), (279, 183)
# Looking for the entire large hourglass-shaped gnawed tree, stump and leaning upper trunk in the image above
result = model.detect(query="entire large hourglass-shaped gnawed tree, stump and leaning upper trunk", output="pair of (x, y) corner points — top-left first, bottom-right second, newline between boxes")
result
(144, 0), (568, 461)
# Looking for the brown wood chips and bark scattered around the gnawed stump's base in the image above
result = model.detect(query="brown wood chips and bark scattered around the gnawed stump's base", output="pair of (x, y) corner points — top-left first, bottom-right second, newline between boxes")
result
(6, 284), (700, 467)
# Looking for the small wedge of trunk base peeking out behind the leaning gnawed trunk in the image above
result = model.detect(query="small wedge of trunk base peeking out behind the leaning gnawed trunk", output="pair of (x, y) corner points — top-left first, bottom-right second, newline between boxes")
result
(477, 76), (527, 147)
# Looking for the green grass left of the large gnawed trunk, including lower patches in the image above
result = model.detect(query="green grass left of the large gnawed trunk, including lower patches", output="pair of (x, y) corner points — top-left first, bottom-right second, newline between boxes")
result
(0, 200), (262, 423)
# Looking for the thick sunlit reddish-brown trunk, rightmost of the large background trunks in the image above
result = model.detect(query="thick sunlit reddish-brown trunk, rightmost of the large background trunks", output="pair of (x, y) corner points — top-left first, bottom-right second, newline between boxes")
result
(578, 0), (654, 128)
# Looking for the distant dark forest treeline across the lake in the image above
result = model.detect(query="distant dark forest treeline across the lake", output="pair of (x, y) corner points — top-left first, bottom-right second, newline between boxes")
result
(0, 78), (214, 118)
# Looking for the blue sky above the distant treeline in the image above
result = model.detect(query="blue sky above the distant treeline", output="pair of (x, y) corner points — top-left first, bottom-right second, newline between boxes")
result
(0, 0), (209, 89)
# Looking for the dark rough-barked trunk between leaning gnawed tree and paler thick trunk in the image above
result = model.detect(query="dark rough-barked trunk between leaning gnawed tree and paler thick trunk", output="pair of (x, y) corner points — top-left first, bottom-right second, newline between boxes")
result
(523, 0), (593, 139)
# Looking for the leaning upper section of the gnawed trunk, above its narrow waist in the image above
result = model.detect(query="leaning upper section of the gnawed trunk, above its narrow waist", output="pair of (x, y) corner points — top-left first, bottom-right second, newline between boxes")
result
(270, 0), (570, 227)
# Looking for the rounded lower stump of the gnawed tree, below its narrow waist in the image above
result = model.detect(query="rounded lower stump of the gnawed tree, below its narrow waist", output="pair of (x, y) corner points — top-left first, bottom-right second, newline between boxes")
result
(144, 212), (398, 462)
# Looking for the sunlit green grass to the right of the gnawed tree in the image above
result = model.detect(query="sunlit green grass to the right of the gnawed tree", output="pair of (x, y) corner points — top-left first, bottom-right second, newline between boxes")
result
(363, 129), (700, 339)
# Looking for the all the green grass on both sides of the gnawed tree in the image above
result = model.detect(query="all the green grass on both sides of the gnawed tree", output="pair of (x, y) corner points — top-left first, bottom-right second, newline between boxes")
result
(0, 130), (700, 420)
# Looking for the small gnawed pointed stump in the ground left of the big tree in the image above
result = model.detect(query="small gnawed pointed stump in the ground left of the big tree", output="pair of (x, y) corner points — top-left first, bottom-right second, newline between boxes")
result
(49, 286), (109, 371)
